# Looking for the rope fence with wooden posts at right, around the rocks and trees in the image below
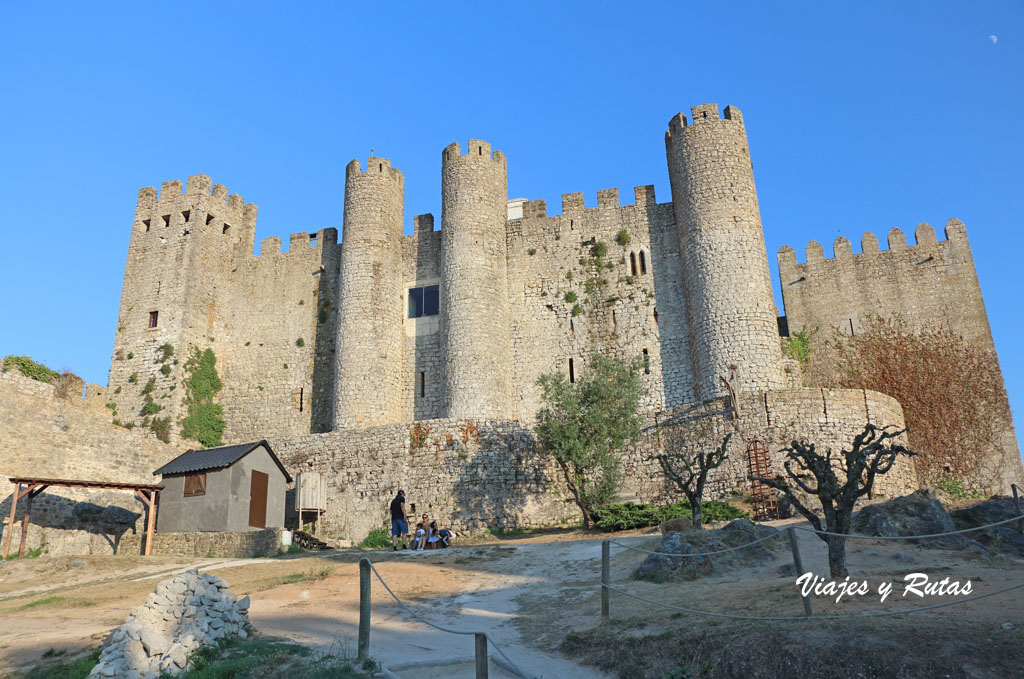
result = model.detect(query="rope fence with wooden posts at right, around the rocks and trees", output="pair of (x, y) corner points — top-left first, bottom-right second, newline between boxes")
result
(601, 512), (1024, 622)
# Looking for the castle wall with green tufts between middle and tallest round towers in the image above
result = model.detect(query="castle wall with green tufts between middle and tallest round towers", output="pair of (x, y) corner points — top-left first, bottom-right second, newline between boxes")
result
(508, 186), (693, 422)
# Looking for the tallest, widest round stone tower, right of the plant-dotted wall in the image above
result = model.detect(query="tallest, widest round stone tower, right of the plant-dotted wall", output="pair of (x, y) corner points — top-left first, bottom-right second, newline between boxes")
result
(665, 103), (783, 400)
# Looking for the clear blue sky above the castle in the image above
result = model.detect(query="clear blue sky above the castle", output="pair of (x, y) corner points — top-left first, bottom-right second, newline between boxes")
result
(0, 0), (1024, 456)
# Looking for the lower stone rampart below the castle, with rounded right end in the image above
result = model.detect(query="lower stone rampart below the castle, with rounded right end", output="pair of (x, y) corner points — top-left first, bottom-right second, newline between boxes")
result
(270, 389), (916, 541)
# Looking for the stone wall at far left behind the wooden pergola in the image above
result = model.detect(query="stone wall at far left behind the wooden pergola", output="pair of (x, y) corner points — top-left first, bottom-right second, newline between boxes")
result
(0, 360), (180, 555)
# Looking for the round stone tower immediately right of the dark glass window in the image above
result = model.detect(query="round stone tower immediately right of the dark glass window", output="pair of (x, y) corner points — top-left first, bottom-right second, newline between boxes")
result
(441, 139), (512, 419)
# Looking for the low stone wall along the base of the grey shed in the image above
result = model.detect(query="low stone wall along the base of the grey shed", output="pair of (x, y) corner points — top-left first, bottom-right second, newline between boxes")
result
(117, 528), (281, 558)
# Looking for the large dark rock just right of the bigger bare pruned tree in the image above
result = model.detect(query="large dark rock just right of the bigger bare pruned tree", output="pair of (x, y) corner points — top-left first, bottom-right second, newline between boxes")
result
(852, 489), (967, 547)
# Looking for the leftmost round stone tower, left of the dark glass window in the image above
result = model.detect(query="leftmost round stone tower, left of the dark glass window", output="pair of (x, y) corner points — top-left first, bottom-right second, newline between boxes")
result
(334, 158), (406, 429)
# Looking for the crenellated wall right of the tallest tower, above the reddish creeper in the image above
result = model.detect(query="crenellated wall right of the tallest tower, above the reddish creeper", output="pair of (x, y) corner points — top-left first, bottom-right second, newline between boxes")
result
(778, 219), (1024, 493)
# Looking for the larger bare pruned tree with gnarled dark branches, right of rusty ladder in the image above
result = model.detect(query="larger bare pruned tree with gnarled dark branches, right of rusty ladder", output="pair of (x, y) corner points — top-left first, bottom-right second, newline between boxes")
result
(750, 424), (916, 578)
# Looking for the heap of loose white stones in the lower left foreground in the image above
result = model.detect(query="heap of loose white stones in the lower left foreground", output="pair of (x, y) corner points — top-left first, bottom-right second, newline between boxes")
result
(89, 569), (249, 679)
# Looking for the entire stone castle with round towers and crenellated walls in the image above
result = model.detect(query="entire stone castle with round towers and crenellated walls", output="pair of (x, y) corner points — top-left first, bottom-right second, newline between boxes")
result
(96, 104), (1020, 536)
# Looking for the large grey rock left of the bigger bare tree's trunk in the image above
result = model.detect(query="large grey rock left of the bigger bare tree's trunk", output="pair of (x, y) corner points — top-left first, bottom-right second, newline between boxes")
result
(636, 519), (784, 582)
